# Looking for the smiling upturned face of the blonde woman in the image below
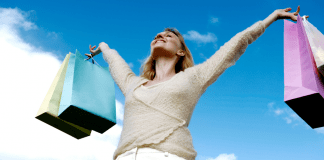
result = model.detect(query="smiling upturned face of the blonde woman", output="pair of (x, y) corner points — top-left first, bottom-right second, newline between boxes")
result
(151, 31), (181, 59)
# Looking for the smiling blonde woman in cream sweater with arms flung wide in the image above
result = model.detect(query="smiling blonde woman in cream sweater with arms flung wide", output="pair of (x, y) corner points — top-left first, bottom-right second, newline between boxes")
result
(86, 6), (308, 160)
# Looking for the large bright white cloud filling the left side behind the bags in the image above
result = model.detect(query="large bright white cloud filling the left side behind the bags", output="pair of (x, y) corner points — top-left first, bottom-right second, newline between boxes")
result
(0, 8), (123, 160)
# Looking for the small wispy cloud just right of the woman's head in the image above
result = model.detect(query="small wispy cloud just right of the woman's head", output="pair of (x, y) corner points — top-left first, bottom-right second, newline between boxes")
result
(183, 30), (217, 44)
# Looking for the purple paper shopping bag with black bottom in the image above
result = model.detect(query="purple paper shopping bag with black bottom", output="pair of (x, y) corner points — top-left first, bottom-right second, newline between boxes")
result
(284, 15), (324, 129)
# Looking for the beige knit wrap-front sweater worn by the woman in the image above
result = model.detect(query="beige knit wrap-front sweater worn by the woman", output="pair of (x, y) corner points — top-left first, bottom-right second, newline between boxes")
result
(101, 21), (265, 160)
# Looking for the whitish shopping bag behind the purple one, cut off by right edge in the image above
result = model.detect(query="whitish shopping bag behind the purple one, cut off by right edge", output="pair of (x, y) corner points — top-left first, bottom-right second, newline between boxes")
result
(303, 17), (324, 75)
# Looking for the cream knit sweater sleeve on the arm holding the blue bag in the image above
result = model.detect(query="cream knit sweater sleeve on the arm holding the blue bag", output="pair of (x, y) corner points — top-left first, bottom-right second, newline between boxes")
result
(101, 45), (136, 96)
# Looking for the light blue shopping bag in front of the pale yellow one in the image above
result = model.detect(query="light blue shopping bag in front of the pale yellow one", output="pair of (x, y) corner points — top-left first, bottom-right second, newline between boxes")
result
(58, 51), (116, 133)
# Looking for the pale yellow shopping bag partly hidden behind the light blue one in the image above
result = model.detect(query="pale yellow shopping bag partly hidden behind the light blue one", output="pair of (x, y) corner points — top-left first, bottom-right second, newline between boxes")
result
(36, 53), (91, 139)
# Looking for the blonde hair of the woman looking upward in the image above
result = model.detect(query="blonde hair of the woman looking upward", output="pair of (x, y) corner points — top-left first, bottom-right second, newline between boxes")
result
(140, 28), (194, 80)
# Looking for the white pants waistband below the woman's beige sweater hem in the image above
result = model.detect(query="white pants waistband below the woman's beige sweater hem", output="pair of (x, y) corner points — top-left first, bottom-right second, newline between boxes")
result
(116, 147), (186, 160)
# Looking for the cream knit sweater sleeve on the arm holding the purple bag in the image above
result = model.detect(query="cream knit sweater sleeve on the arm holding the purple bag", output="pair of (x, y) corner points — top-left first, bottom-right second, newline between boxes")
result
(194, 21), (265, 91)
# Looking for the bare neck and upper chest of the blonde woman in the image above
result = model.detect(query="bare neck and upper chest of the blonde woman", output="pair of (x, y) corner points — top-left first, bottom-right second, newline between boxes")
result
(153, 56), (177, 81)
